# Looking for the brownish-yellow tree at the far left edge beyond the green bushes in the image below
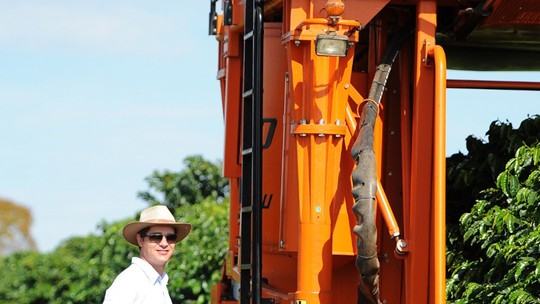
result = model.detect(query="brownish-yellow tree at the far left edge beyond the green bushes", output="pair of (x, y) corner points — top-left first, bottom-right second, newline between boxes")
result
(0, 199), (36, 256)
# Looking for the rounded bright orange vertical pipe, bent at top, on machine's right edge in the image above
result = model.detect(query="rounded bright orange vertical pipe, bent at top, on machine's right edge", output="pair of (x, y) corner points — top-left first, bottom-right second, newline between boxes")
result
(433, 45), (446, 303)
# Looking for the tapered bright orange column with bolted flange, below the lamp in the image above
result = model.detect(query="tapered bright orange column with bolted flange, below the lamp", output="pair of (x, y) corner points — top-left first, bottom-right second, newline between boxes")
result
(286, 18), (353, 304)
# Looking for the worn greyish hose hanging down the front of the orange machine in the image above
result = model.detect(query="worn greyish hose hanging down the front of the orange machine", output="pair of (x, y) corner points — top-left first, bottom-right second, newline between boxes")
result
(351, 29), (410, 304)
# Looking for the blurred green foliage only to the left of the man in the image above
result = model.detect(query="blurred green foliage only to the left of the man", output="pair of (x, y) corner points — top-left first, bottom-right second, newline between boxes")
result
(0, 220), (137, 304)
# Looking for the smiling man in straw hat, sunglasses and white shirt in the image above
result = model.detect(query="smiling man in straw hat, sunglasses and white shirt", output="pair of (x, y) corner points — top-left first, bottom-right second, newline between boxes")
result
(103, 206), (191, 304)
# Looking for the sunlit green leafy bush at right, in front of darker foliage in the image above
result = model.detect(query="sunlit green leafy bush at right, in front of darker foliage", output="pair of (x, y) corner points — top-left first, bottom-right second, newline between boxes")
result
(447, 143), (540, 304)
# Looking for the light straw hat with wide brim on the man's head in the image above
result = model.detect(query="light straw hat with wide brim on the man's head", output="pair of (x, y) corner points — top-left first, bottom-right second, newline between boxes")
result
(122, 205), (191, 245)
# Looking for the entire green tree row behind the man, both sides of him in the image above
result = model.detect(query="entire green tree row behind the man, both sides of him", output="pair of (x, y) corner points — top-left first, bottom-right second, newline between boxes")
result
(0, 156), (228, 304)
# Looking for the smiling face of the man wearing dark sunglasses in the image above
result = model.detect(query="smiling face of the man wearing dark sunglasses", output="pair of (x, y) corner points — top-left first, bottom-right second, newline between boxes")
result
(137, 226), (176, 272)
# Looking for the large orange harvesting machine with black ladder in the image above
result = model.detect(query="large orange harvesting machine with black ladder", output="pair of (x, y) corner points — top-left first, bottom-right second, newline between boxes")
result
(209, 0), (540, 304)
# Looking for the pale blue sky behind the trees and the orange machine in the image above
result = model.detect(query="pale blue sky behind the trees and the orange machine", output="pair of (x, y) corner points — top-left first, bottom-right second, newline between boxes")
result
(0, 0), (540, 251)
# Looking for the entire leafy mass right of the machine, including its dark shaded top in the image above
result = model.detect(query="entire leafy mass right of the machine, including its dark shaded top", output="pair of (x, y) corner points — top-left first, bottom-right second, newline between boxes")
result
(446, 115), (540, 304)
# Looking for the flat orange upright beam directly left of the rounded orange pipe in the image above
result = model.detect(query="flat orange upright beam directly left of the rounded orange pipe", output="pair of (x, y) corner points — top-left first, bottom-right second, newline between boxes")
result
(405, 0), (437, 304)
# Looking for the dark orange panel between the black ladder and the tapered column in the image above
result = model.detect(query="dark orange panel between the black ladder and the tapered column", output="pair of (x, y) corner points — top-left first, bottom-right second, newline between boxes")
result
(262, 23), (297, 294)
